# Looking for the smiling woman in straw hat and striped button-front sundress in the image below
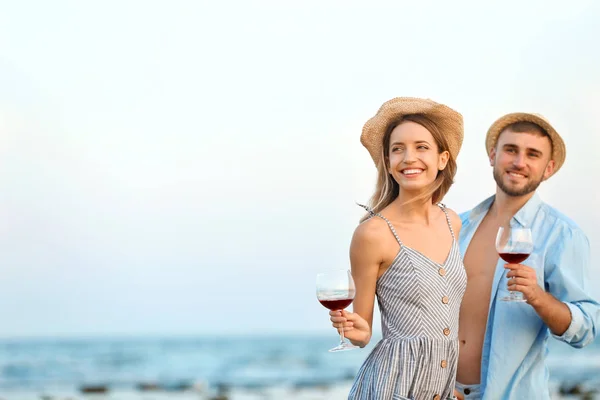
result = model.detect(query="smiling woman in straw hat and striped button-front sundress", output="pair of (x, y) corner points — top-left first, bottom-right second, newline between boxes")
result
(330, 98), (467, 400)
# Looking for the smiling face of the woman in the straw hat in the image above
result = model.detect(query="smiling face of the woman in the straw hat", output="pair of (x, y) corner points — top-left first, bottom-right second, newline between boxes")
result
(387, 121), (449, 192)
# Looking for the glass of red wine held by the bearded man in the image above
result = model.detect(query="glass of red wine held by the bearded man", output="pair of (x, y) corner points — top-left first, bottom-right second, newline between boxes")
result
(496, 226), (533, 302)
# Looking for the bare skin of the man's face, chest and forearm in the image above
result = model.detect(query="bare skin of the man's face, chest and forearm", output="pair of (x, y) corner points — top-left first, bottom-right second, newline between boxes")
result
(457, 130), (571, 384)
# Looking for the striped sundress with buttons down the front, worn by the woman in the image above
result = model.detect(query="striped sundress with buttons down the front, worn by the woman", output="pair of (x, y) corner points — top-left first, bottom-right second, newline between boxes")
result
(348, 204), (467, 400)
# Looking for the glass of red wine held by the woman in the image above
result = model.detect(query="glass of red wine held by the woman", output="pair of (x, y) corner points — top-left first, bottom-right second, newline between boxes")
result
(317, 270), (358, 352)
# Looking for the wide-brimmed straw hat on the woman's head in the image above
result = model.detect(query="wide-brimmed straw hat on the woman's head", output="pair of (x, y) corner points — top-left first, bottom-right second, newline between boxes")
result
(360, 97), (463, 165)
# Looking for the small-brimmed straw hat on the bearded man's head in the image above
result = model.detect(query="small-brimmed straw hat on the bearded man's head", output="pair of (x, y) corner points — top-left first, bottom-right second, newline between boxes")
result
(485, 113), (567, 176)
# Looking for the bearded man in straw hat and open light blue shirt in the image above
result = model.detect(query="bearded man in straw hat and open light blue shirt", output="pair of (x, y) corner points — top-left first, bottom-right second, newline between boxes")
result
(457, 113), (600, 400)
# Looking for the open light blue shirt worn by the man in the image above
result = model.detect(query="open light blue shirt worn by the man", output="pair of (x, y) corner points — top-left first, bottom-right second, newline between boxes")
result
(459, 193), (600, 400)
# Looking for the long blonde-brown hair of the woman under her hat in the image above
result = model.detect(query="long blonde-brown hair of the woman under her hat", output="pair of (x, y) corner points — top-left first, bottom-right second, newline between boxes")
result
(361, 114), (456, 222)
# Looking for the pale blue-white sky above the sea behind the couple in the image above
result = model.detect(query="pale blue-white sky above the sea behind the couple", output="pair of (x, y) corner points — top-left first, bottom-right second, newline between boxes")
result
(0, 0), (600, 337)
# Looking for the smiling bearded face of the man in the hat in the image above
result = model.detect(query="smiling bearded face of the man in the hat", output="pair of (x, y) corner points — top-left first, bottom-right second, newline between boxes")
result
(490, 128), (554, 197)
